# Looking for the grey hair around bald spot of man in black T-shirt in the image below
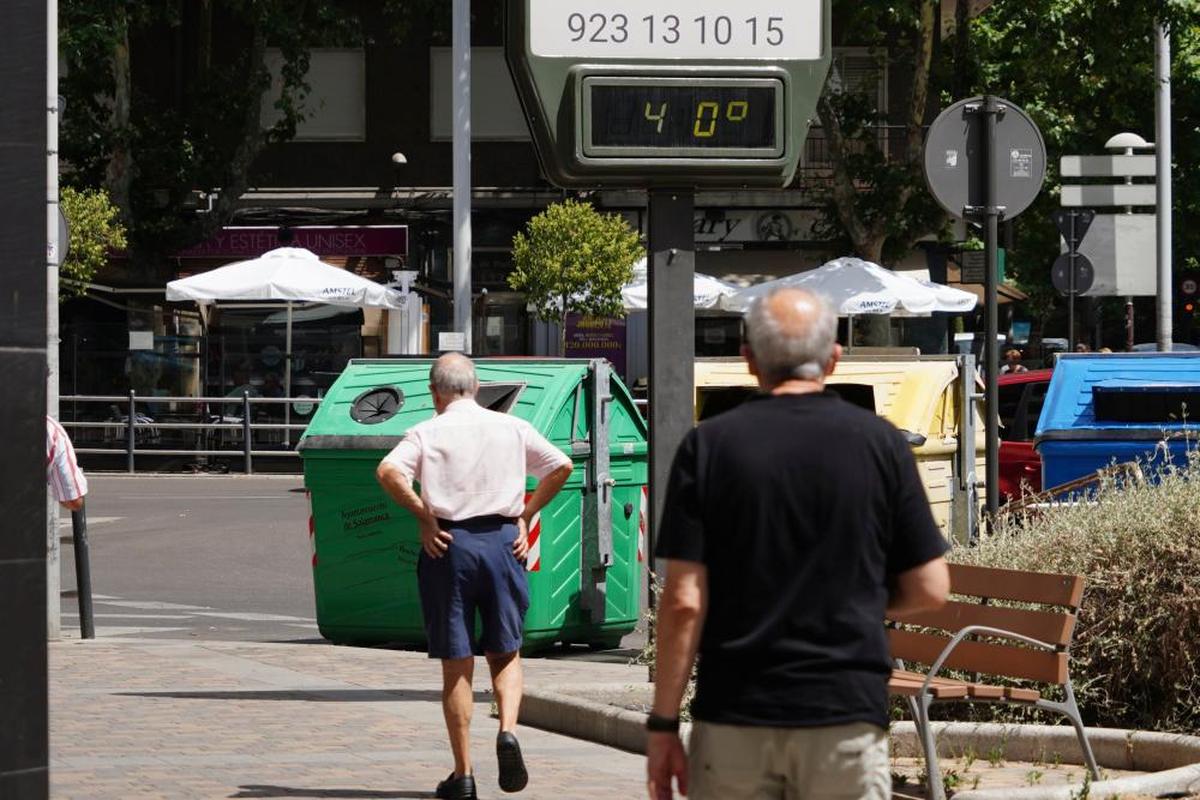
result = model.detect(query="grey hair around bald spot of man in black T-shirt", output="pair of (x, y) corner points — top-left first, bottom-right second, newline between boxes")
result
(745, 288), (838, 385)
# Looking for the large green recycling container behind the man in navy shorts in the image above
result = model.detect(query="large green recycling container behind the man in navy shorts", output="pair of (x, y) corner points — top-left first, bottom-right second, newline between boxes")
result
(299, 359), (648, 650)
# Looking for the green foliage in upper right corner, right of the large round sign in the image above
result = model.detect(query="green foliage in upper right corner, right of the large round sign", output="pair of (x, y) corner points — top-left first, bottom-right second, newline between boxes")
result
(964, 0), (1200, 318)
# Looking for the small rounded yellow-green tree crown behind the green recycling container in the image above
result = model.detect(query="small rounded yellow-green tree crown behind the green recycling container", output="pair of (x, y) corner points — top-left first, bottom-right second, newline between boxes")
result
(509, 200), (646, 352)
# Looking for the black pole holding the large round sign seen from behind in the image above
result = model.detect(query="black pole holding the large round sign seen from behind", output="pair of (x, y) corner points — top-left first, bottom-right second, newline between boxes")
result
(983, 95), (1003, 519)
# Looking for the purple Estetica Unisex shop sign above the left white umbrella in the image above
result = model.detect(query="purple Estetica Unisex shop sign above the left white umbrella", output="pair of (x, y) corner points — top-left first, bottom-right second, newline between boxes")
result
(176, 225), (408, 259)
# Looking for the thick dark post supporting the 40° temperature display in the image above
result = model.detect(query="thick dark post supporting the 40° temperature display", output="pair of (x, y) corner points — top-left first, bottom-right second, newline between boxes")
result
(646, 190), (696, 678)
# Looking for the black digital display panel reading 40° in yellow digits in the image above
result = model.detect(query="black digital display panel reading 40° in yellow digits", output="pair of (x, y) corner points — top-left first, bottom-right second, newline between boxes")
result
(584, 78), (784, 158)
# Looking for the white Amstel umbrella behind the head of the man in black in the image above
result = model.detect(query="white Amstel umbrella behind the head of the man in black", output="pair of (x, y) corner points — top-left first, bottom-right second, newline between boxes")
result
(721, 258), (979, 343)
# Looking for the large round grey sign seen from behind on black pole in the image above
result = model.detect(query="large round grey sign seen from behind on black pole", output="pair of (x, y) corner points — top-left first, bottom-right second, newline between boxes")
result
(925, 97), (1046, 219)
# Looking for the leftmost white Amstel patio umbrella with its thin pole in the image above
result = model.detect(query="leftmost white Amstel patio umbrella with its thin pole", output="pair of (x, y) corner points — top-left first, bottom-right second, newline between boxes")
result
(167, 247), (406, 444)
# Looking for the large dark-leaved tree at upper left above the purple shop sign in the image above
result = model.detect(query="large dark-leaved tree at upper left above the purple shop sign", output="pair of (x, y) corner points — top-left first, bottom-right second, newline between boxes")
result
(60, 0), (445, 277)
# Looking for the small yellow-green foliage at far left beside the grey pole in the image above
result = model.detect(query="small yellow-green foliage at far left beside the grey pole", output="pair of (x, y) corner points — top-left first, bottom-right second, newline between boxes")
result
(59, 186), (126, 297)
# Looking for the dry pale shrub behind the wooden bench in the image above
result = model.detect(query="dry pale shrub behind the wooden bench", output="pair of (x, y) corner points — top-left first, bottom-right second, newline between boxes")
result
(952, 452), (1200, 733)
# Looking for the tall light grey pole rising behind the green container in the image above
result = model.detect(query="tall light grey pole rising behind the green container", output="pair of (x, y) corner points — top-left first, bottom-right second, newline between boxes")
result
(451, 0), (472, 353)
